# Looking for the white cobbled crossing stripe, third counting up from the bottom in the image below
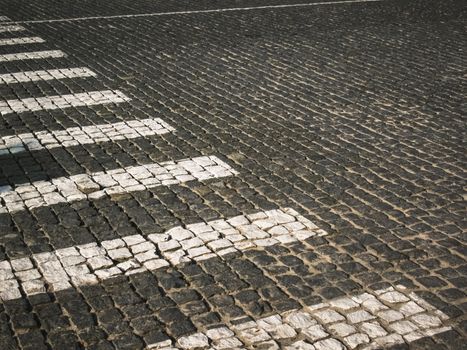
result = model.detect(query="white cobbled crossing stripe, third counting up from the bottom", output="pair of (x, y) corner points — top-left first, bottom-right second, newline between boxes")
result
(0, 156), (237, 213)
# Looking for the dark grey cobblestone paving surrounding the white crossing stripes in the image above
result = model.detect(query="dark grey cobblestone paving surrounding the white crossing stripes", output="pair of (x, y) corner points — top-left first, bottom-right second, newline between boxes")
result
(0, 0), (467, 350)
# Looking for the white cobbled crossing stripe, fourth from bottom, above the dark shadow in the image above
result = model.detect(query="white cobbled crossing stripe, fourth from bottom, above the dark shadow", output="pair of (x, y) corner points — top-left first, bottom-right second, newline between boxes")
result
(0, 118), (175, 155)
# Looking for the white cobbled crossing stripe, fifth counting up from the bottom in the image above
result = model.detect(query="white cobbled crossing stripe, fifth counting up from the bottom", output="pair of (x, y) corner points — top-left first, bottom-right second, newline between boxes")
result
(0, 90), (130, 115)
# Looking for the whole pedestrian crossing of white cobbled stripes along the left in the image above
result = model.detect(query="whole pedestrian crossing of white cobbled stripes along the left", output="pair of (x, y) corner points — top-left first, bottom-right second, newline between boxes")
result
(0, 13), (456, 350)
